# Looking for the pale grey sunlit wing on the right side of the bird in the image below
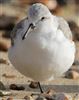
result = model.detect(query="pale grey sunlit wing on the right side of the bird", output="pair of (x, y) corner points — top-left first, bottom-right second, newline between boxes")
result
(58, 17), (73, 40)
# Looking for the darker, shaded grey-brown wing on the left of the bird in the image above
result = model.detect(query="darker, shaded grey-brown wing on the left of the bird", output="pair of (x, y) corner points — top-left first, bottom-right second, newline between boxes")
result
(11, 18), (27, 46)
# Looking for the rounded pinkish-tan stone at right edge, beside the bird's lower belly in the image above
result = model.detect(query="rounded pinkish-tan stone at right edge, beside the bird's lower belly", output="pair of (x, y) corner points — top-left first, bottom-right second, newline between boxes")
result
(65, 70), (79, 79)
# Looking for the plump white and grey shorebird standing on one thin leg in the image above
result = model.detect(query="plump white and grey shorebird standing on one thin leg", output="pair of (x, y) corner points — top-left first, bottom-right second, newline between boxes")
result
(8, 3), (76, 92)
